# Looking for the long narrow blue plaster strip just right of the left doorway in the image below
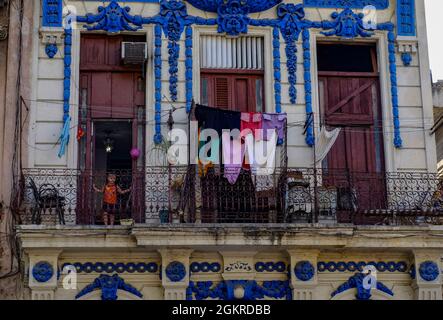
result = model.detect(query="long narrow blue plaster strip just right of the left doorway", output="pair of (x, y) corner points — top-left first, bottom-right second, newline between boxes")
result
(154, 24), (163, 144)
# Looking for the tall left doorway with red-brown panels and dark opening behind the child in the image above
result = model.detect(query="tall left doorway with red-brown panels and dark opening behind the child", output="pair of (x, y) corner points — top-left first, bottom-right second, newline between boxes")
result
(77, 34), (146, 224)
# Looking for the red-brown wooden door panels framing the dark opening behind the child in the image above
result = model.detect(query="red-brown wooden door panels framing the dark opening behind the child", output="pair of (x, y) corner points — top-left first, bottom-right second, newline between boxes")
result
(77, 35), (145, 224)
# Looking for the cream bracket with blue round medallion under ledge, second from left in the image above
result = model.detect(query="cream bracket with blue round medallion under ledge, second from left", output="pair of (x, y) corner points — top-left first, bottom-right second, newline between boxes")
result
(159, 249), (193, 300)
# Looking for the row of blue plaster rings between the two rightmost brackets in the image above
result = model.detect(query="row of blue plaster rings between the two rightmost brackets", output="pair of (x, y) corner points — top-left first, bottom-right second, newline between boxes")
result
(317, 261), (408, 273)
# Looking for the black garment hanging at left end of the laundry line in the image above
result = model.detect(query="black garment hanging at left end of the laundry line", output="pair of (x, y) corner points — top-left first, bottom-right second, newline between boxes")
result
(195, 104), (241, 138)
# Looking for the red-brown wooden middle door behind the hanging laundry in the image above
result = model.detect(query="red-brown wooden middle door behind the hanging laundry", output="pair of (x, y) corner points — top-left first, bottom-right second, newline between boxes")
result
(201, 70), (269, 223)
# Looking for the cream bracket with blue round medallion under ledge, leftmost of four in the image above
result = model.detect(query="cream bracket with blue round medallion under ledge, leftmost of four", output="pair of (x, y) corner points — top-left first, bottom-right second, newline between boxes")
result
(27, 250), (62, 300)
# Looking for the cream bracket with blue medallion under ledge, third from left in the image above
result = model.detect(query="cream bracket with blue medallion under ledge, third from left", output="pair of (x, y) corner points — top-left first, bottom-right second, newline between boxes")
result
(287, 249), (319, 300)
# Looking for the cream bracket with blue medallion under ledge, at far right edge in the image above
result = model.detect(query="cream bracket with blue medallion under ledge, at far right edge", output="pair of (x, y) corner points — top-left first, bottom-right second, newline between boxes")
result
(412, 250), (442, 300)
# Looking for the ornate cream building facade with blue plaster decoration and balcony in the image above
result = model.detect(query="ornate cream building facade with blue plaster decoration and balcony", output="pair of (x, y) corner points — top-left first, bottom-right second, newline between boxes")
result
(7, 0), (443, 300)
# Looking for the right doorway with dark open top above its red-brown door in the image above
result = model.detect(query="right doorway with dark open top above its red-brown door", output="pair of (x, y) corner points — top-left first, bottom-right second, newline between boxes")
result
(317, 42), (386, 223)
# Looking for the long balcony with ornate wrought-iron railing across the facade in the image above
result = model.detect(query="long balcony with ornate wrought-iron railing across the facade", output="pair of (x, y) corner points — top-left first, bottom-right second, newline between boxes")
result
(16, 166), (443, 225)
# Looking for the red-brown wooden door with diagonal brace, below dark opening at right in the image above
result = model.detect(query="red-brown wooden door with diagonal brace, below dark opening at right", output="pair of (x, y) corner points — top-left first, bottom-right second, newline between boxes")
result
(319, 72), (386, 223)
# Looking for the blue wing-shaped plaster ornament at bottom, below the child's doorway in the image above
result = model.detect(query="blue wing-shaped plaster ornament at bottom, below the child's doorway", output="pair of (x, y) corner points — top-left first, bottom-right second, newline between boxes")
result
(75, 274), (143, 300)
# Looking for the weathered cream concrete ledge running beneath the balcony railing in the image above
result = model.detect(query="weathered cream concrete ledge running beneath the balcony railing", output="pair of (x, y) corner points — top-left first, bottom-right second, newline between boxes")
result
(17, 224), (443, 250)
